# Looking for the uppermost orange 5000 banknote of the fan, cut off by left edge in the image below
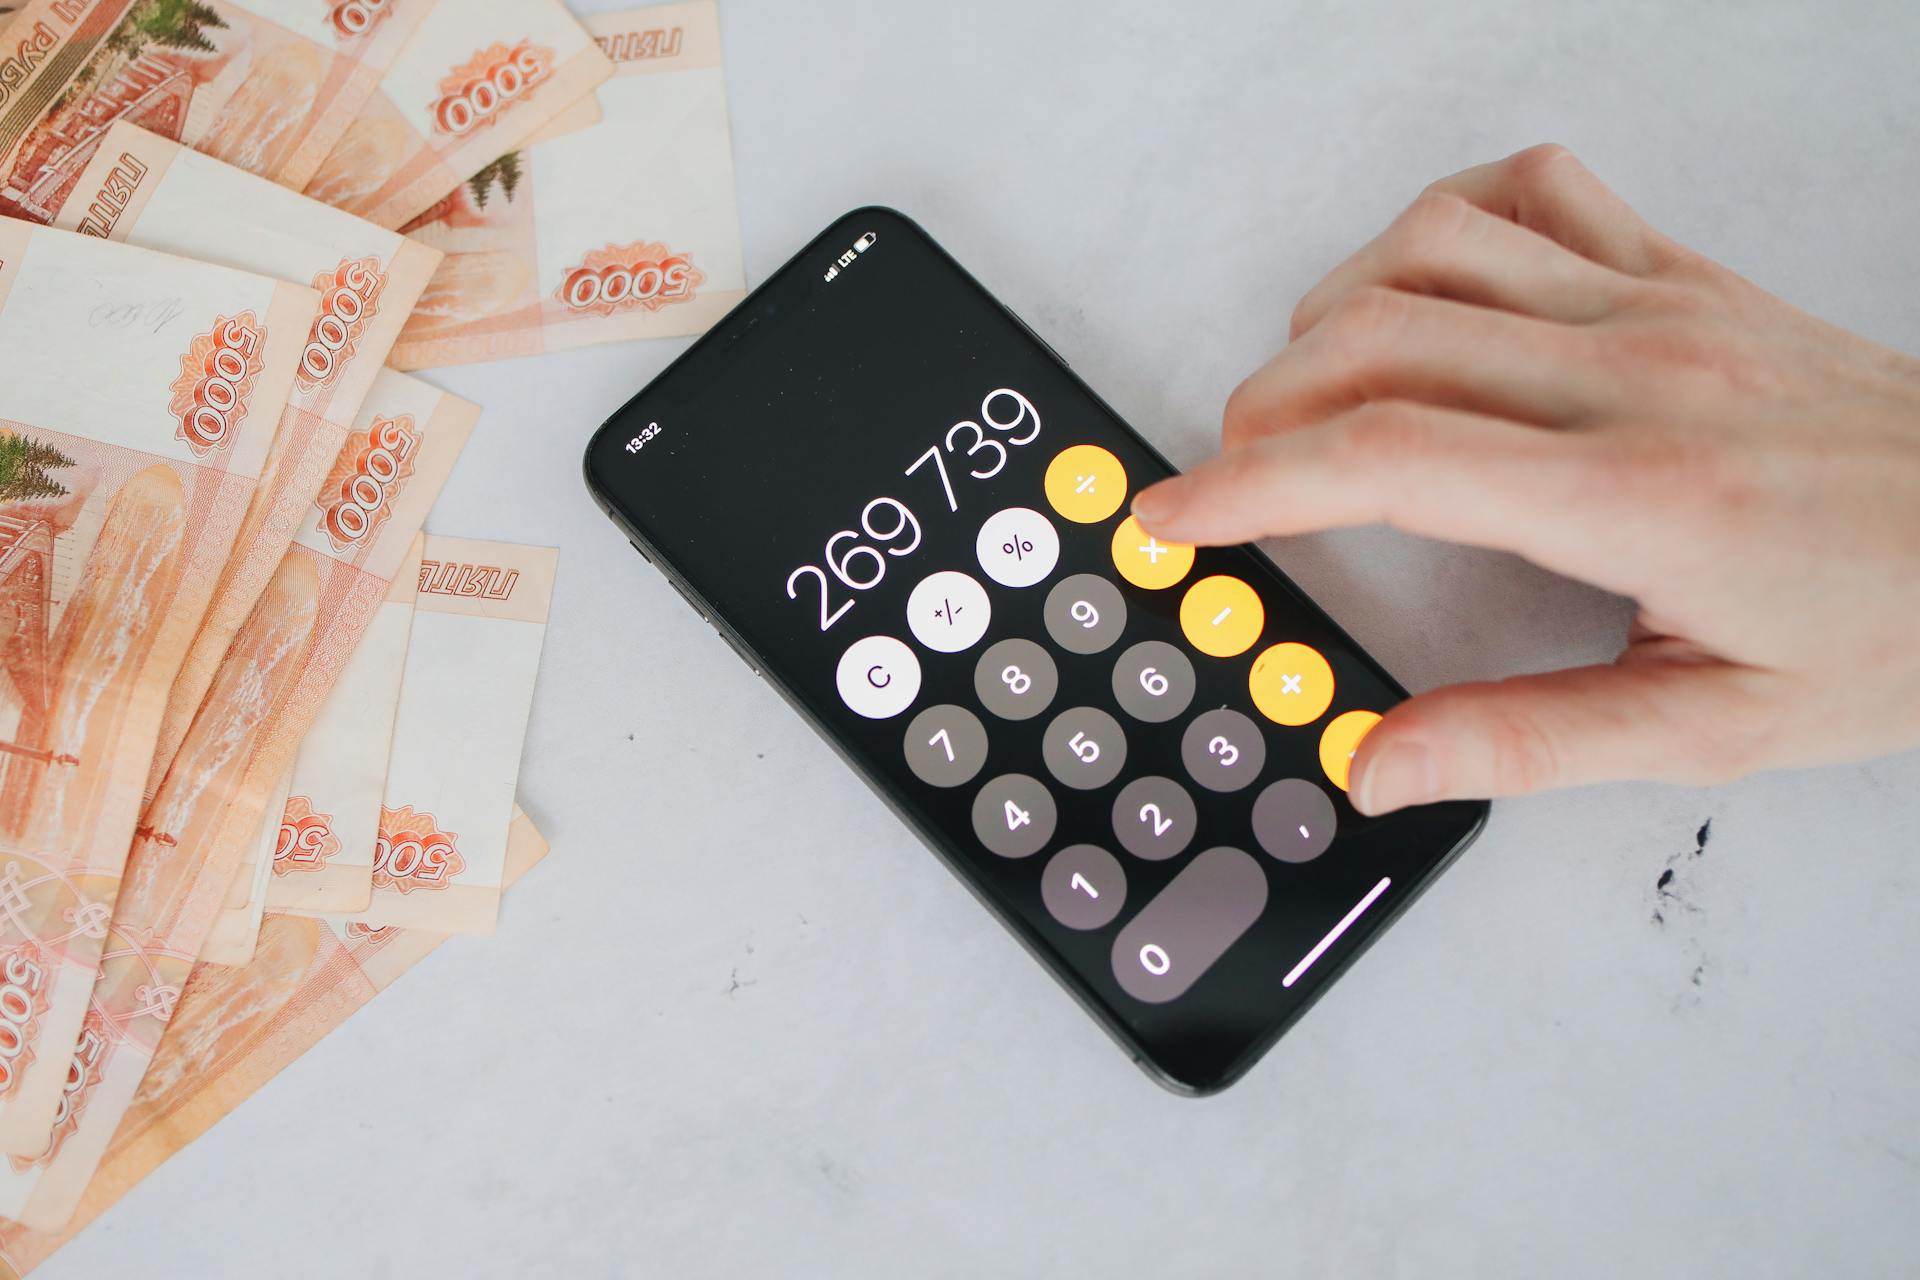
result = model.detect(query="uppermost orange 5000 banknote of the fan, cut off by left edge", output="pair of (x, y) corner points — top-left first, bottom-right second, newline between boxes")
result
(0, 219), (321, 1151)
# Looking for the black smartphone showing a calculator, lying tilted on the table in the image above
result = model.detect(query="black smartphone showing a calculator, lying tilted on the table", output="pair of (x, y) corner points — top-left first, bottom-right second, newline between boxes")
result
(586, 207), (1486, 1094)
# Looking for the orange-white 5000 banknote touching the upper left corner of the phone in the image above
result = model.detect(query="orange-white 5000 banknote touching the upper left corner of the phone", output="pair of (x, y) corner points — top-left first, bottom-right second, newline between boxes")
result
(392, 0), (747, 368)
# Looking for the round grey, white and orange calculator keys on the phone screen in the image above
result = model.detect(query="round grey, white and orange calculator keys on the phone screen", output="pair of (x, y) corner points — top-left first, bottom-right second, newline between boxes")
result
(879, 441), (1379, 1004)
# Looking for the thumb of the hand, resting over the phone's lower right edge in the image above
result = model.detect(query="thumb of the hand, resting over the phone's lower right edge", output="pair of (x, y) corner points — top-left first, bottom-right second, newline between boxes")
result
(1352, 660), (1763, 814)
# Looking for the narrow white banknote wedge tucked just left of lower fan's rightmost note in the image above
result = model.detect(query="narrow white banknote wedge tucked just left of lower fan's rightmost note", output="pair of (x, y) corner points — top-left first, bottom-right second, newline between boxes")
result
(264, 537), (422, 917)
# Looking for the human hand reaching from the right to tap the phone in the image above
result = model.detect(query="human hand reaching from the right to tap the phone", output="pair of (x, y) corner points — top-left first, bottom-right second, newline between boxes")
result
(1135, 146), (1920, 814)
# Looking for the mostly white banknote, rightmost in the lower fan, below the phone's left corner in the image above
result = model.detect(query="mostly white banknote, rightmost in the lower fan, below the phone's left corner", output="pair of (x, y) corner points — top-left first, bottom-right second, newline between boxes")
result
(353, 533), (559, 933)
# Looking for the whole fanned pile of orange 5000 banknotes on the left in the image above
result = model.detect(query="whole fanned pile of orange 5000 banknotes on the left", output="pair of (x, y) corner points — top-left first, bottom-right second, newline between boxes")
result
(0, 0), (745, 1274)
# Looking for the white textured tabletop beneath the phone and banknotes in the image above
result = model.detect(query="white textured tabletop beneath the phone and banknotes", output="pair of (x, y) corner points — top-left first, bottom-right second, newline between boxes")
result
(44, 0), (1920, 1278)
